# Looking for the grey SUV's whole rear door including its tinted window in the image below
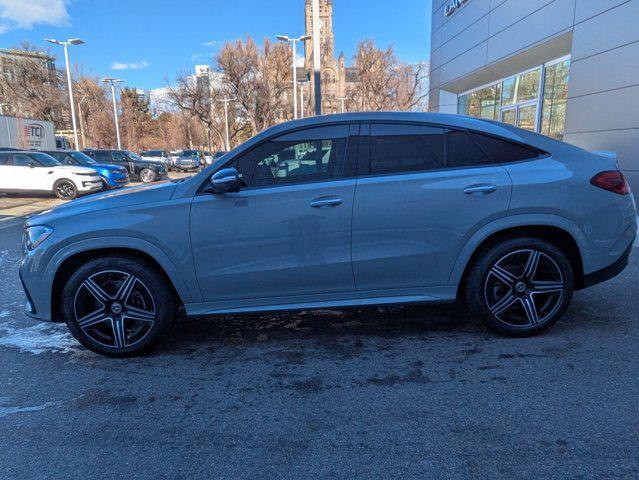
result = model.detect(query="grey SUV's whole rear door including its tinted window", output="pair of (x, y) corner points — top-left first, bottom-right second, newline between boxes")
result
(353, 125), (512, 292)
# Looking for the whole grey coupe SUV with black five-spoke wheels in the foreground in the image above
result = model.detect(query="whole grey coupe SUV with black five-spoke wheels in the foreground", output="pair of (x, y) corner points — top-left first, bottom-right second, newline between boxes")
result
(20, 113), (637, 357)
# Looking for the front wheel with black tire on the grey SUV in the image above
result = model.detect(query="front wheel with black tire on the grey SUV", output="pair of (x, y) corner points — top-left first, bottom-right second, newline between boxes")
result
(62, 255), (177, 357)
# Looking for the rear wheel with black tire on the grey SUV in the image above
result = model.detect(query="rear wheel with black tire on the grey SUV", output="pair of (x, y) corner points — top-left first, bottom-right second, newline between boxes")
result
(464, 238), (574, 337)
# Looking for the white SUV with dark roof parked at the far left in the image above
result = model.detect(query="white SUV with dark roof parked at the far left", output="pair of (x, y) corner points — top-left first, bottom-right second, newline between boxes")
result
(0, 150), (102, 200)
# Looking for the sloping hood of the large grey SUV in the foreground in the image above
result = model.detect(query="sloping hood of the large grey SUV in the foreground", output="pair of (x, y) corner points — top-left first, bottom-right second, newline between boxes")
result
(26, 181), (177, 226)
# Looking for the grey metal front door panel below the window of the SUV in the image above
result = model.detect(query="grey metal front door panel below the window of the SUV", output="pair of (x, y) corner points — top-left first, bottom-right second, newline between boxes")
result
(191, 179), (355, 302)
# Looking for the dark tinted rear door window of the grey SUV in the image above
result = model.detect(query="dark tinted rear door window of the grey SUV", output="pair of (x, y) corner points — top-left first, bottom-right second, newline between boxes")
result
(370, 124), (445, 175)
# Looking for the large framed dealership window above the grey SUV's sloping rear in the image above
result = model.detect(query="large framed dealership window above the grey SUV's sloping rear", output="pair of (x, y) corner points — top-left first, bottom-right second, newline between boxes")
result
(457, 58), (570, 139)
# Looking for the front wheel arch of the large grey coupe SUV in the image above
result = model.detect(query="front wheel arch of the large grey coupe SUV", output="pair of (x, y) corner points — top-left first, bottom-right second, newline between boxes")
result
(51, 245), (192, 321)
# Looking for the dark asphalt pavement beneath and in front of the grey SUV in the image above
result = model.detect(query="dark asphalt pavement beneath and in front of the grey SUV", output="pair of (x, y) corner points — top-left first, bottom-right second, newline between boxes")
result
(0, 204), (639, 479)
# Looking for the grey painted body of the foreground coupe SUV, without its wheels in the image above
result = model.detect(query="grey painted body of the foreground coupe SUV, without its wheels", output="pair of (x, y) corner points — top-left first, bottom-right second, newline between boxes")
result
(20, 113), (637, 352)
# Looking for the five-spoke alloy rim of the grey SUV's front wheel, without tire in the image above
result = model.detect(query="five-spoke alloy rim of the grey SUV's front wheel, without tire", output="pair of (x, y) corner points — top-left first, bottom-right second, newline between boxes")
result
(73, 270), (156, 349)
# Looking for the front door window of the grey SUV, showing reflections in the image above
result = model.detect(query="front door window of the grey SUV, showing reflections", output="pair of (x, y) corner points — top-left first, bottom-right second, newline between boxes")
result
(237, 126), (348, 187)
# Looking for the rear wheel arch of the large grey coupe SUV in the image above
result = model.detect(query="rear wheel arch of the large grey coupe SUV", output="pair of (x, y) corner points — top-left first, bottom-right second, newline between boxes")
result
(450, 215), (585, 296)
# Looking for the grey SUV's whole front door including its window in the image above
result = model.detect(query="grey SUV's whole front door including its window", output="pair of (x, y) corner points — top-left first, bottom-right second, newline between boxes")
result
(191, 125), (357, 304)
